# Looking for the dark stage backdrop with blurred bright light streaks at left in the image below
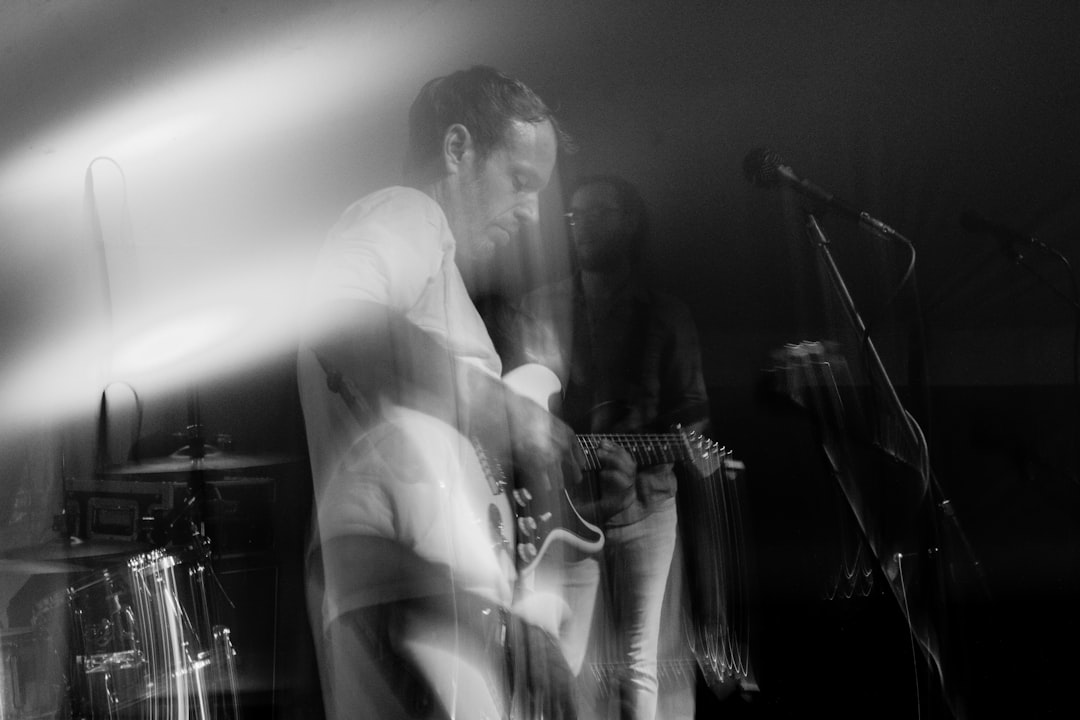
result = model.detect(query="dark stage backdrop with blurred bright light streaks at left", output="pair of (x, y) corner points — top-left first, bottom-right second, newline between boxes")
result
(0, 0), (1080, 717)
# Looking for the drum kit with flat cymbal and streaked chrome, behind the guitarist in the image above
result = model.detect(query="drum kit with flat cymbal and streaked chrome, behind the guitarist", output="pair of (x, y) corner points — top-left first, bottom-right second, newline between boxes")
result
(0, 436), (300, 720)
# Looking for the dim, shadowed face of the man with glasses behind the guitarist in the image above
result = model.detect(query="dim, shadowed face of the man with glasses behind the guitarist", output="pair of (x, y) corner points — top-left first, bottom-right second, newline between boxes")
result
(570, 182), (633, 272)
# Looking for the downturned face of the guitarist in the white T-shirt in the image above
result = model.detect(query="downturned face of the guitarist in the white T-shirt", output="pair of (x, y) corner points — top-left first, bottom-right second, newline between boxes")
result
(442, 121), (557, 274)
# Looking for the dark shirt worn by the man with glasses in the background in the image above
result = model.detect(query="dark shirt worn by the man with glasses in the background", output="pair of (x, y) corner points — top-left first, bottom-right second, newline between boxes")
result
(504, 275), (708, 526)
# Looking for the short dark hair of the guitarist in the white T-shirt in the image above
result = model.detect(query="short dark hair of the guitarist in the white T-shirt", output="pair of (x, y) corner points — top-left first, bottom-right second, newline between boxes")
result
(405, 65), (569, 179)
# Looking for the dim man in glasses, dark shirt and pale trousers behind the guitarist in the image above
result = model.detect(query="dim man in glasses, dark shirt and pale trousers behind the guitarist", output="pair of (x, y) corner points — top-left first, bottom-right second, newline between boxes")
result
(508, 175), (710, 720)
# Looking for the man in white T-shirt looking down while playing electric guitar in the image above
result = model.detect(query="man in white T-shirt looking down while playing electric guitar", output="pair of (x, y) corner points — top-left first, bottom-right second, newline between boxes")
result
(297, 67), (630, 718)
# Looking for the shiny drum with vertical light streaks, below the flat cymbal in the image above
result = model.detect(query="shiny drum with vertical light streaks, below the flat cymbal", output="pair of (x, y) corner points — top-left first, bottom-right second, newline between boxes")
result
(29, 539), (239, 719)
